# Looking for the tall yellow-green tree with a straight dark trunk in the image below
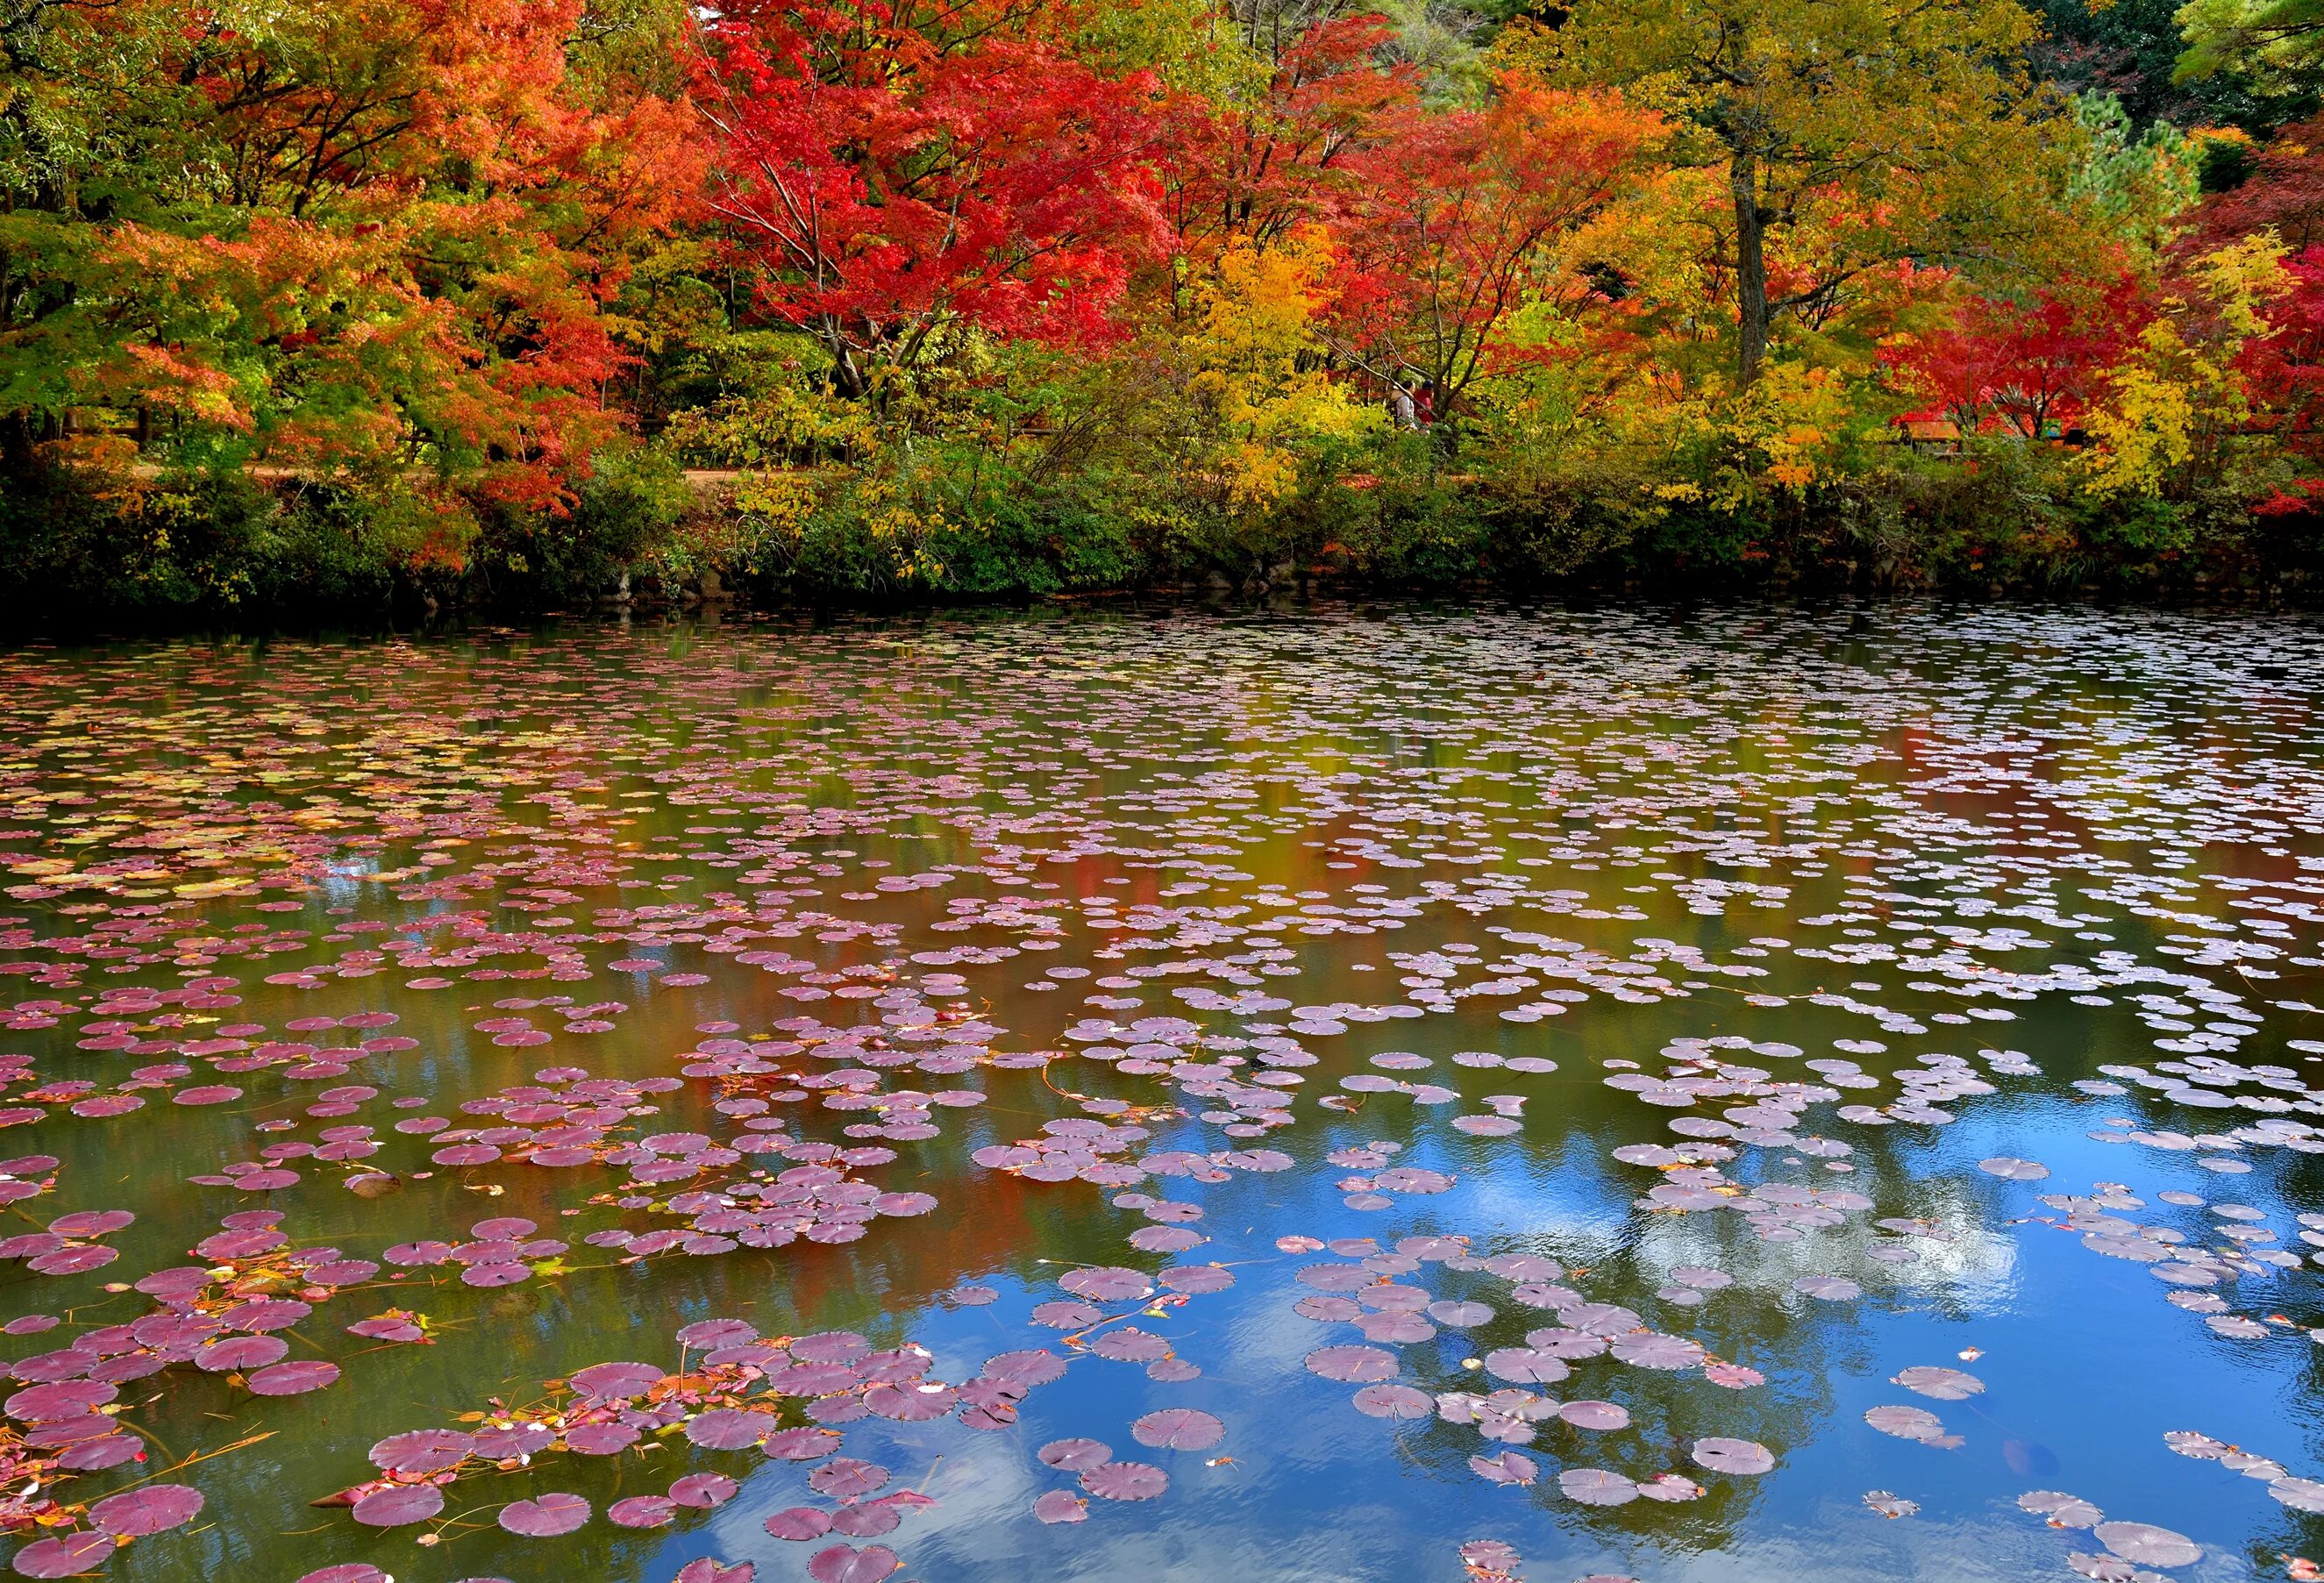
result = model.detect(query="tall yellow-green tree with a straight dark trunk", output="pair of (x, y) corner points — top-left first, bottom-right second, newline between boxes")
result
(1534, 0), (2073, 386)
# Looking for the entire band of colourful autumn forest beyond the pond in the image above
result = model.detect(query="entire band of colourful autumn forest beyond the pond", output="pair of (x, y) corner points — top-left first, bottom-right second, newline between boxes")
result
(0, 0), (2324, 625)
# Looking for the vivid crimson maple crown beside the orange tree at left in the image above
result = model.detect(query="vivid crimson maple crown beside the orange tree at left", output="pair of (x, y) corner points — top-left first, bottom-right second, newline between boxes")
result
(702, 0), (1162, 389)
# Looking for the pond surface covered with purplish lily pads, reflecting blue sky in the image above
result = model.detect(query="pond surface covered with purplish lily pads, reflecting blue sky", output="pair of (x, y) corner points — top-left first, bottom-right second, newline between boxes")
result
(0, 607), (2324, 1583)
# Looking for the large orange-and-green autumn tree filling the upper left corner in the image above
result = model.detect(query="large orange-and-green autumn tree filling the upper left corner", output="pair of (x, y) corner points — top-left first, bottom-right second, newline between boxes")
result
(0, 0), (702, 507)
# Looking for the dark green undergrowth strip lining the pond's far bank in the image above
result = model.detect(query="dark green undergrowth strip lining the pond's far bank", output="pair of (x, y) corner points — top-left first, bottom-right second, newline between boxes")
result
(0, 442), (2324, 632)
